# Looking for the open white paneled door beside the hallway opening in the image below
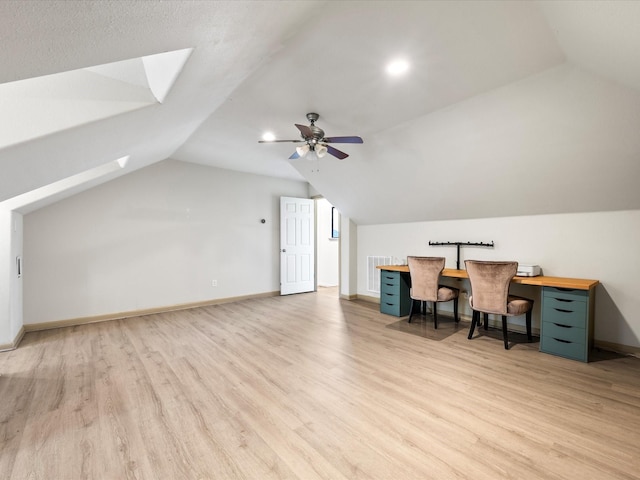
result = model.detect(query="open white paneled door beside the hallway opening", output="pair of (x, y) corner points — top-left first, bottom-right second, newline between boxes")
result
(280, 197), (315, 295)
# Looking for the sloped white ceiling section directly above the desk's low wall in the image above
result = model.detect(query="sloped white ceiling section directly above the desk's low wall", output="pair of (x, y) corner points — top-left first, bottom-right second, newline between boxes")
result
(300, 65), (640, 225)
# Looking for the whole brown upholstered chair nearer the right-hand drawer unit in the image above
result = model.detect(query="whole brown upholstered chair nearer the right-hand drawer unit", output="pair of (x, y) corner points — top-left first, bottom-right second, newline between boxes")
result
(464, 260), (533, 350)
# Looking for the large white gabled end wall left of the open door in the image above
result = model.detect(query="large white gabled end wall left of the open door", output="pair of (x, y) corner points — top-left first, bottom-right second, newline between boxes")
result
(24, 160), (308, 324)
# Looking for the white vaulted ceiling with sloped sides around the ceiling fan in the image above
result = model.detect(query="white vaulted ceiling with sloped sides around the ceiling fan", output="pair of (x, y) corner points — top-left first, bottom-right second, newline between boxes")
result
(0, 0), (640, 224)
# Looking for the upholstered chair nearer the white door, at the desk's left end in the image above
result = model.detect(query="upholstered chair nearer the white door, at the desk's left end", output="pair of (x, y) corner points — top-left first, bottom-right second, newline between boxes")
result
(407, 257), (460, 328)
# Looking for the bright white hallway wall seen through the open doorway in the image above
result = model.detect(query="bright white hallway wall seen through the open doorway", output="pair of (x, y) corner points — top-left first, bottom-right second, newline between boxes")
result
(316, 198), (339, 287)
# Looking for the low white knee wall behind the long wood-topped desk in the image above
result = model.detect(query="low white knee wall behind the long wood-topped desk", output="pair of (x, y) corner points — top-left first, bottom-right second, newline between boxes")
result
(358, 210), (640, 347)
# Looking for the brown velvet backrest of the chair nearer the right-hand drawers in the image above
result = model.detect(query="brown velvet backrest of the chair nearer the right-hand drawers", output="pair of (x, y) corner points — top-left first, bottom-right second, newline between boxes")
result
(464, 260), (518, 315)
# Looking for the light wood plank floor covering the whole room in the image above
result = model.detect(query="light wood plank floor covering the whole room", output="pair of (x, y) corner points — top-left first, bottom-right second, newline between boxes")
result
(0, 290), (640, 480)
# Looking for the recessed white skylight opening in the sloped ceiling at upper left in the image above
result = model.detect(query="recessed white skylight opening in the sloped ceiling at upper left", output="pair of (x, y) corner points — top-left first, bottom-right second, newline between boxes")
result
(0, 48), (193, 148)
